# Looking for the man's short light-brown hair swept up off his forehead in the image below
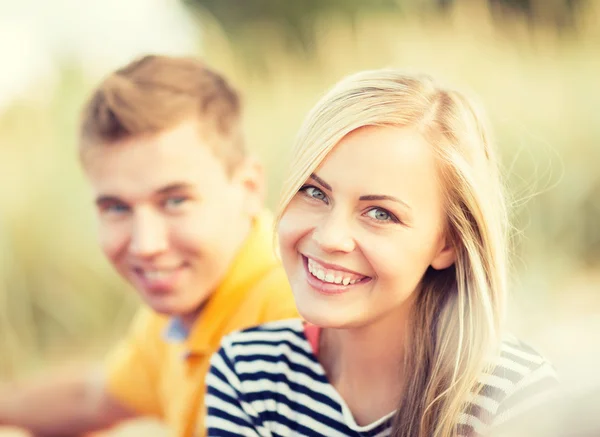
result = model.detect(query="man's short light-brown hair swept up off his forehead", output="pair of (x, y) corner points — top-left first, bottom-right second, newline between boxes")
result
(80, 55), (246, 169)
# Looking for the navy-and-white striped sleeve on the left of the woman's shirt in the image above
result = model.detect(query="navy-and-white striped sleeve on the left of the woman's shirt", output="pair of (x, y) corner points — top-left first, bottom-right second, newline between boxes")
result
(205, 341), (264, 437)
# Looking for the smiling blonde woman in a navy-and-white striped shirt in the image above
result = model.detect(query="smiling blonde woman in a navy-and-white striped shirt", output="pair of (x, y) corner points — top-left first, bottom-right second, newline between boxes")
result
(206, 70), (556, 437)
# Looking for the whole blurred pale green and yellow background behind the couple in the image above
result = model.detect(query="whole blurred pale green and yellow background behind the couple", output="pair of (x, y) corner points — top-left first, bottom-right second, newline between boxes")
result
(0, 0), (600, 430)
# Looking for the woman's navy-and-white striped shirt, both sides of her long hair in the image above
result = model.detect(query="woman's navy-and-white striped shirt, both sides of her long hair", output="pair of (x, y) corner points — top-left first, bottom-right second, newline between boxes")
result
(206, 320), (556, 437)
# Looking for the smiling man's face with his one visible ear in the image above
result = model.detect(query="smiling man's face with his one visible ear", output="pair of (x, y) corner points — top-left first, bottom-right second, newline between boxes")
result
(83, 117), (263, 317)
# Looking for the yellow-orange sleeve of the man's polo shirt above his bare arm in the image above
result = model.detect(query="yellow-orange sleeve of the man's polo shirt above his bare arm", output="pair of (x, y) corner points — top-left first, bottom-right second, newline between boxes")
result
(105, 309), (162, 417)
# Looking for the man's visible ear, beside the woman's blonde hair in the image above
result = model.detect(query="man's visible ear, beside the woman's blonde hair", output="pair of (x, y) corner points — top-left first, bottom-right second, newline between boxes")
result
(233, 156), (266, 217)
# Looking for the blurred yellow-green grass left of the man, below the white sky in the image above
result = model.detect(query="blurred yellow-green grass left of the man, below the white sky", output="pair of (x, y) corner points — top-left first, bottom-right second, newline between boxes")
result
(0, 62), (141, 381)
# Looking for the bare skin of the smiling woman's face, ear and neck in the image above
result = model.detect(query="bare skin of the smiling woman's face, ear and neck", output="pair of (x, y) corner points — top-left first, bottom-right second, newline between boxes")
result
(278, 127), (454, 425)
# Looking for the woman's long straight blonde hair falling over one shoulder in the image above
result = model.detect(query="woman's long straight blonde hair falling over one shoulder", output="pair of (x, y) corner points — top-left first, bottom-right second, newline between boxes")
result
(278, 70), (507, 437)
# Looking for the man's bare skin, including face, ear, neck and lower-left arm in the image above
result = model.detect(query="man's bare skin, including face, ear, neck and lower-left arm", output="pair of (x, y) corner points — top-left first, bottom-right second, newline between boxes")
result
(0, 119), (264, 436)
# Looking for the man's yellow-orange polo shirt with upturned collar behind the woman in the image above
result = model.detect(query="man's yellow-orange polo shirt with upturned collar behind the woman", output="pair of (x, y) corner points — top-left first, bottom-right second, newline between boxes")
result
(107, 216), (298, 437)
